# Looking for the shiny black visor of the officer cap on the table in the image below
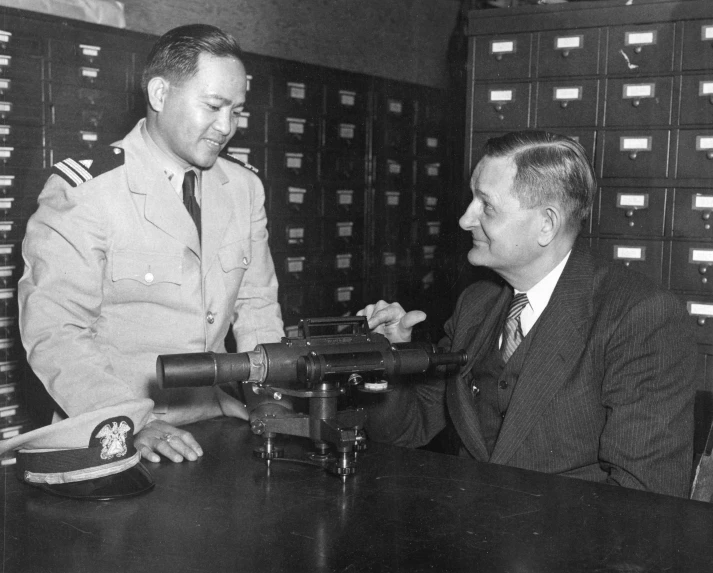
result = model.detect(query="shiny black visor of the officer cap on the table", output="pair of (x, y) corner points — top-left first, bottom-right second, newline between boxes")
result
(32, 463), (155, 501)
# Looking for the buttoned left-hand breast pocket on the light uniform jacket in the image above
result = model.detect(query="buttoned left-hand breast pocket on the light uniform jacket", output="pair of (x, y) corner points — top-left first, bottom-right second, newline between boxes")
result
(111, 251), (183, 304)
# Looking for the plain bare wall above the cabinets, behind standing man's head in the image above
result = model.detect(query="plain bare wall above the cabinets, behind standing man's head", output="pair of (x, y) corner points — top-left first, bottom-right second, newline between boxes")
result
(123, 0), (460, 87)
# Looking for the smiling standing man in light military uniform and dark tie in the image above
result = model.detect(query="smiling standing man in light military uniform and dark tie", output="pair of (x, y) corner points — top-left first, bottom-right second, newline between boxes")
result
(19, 25), (283, 462)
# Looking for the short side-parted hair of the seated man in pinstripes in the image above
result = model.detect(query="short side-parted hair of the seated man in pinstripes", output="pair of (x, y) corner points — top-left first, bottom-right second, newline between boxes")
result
(483, 131), (597, 231)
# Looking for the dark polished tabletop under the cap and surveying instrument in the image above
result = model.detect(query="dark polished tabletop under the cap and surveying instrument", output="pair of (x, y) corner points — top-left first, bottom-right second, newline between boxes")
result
(1, 419), (713, 573)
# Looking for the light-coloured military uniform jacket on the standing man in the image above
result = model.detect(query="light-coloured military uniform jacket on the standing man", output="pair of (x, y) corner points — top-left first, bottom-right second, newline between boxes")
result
(18, 120), (283, 415)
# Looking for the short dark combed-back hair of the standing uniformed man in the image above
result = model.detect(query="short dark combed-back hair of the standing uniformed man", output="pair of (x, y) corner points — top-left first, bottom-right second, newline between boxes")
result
(141, 24), (243, 101)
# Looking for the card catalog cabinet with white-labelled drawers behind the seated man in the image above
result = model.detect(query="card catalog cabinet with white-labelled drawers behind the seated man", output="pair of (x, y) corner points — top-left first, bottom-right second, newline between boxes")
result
(460, 0), (713, 390)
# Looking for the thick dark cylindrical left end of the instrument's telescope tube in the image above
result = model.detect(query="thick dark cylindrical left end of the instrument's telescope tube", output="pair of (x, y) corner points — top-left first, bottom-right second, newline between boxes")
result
(156, 352), (250, 388)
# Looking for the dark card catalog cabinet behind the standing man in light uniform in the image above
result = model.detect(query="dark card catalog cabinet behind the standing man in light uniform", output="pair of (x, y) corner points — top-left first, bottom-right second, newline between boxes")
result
(0, 3), (456, 446)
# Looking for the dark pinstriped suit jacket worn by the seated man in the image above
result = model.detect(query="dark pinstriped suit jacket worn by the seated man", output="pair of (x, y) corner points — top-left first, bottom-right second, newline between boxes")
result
(368, 242), (696, 496)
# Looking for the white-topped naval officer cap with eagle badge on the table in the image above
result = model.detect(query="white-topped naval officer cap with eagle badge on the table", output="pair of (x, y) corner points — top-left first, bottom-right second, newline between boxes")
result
(0, 399), (154, 500)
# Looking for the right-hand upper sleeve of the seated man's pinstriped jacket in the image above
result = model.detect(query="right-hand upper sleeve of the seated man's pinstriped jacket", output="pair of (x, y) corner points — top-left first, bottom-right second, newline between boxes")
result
(599, 291), (696, 497)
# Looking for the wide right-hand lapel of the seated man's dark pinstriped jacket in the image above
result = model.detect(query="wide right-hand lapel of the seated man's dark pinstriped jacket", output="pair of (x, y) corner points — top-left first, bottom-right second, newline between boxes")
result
(490, 248), (593, 464)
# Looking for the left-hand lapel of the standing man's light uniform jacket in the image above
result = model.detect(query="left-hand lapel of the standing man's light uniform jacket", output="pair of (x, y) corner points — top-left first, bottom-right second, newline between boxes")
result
(123, 122), (201, 257)
